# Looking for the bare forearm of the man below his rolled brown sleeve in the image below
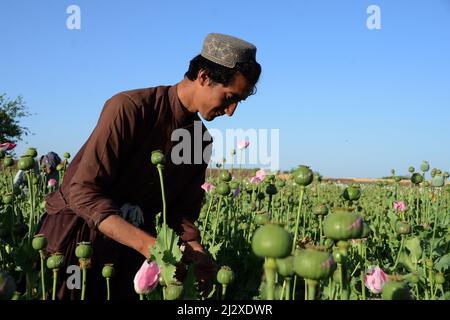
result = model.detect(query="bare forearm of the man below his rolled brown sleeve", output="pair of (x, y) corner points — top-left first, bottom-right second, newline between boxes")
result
(98, 214), (156, 258)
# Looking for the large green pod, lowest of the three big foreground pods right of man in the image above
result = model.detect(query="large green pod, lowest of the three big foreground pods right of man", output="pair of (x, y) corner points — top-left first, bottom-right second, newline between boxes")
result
(294, 248), (336, 280)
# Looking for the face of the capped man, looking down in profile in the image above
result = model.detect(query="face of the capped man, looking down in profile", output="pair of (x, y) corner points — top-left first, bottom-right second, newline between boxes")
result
(196, 71), (250, 121)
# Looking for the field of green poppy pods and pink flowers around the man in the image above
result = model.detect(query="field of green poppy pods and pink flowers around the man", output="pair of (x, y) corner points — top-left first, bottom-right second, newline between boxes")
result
(0, 144), (450, 300)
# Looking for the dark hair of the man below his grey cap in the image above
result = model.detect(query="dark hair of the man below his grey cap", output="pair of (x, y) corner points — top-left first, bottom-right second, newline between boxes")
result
(184, 55), (261, 94)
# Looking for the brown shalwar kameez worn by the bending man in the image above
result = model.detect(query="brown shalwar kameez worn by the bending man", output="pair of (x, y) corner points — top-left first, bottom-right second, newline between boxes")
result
(39, 86), (211, 300)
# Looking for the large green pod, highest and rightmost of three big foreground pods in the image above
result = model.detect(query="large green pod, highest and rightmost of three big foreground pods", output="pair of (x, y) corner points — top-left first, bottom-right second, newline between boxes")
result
(323, 208), (363, 241)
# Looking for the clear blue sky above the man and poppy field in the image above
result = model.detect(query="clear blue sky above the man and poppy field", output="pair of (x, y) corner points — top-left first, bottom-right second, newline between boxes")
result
(0, 0), (450, 177)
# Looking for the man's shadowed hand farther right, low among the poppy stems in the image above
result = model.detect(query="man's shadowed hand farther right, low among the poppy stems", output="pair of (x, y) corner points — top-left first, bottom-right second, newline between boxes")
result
(178, 241), (217, 296)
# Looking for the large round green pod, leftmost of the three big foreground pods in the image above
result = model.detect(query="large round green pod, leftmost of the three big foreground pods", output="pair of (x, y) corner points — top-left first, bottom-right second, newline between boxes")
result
(252, 223), (292, 259)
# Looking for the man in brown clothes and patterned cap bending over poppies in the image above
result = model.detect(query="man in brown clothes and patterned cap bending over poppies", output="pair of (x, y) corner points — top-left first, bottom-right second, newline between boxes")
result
(39, 34), (261, 299)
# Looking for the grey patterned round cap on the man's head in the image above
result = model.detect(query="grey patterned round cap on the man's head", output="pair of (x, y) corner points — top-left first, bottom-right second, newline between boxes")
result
(200, 33), (256, 68)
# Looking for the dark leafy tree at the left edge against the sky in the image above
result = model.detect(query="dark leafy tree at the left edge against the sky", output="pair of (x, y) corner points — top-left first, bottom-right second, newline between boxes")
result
(0, 94), (30, 143)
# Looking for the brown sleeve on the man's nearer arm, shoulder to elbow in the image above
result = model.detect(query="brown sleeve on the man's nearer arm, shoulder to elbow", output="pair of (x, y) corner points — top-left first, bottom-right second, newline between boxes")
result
(69, 94), (138, 229)
